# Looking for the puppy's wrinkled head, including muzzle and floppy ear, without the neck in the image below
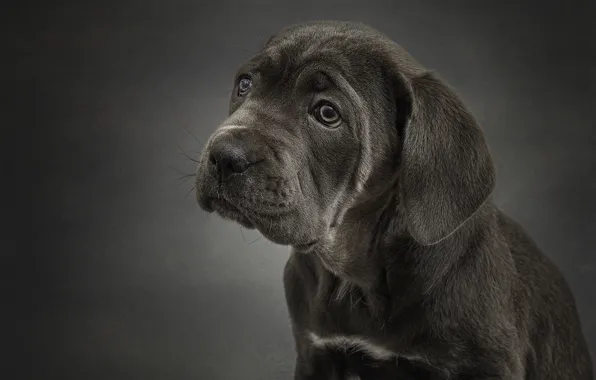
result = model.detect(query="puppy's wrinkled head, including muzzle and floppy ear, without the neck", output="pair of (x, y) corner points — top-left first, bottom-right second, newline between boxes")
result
(197, 22), (495, 250)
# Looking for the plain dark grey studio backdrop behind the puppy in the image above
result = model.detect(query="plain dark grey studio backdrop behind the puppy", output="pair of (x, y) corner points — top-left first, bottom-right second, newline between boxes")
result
(16, 0), (596, 380)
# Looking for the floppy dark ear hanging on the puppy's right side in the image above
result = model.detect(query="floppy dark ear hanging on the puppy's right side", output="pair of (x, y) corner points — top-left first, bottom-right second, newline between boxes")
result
(400, 73), (495, 245)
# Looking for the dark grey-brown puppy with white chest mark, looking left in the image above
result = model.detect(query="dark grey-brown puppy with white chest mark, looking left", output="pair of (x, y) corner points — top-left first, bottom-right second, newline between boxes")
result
(196, 21), (593, 380)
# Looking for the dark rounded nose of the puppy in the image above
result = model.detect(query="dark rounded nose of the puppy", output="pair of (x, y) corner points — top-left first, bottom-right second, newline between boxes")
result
(209, 138), (253, 180)
